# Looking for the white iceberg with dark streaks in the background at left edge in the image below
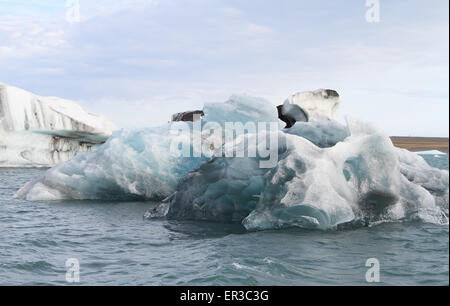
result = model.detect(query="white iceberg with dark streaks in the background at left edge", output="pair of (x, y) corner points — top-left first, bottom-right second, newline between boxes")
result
(0, 84), (115, 167)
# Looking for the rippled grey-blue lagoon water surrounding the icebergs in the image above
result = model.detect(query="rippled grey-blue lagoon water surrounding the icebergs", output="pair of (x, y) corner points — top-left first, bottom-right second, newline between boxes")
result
(0, 155), (449, 286)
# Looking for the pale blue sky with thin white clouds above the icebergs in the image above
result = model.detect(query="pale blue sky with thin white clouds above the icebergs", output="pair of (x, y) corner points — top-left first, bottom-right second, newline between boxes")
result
(0, 0), (449, 137)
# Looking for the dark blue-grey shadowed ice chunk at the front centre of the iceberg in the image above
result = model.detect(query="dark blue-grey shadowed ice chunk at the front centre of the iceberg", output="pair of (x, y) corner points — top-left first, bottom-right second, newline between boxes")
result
(145, 132), (286, 222)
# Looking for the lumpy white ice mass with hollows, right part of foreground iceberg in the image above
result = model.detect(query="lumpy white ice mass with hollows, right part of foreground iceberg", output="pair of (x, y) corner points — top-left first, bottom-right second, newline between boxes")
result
(246, 121), (448, 230)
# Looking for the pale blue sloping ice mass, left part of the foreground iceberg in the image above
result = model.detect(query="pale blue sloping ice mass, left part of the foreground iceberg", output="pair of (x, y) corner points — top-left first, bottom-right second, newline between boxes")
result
(16, 123), (210, 201)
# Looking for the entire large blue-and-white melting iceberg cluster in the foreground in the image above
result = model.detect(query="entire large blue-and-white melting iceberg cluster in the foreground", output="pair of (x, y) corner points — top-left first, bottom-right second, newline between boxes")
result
(16, 96), (449, 230)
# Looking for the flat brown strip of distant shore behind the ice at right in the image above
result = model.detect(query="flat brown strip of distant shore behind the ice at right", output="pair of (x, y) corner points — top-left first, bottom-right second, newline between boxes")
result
(391, 136), (448, 153)
